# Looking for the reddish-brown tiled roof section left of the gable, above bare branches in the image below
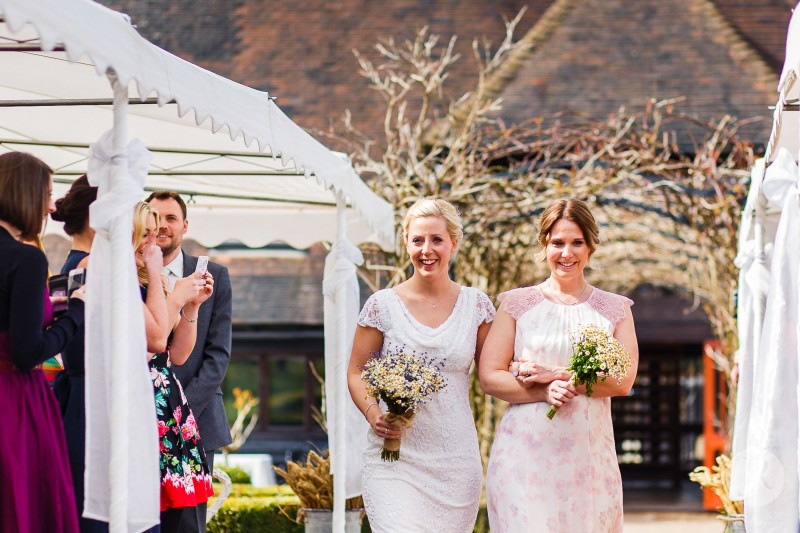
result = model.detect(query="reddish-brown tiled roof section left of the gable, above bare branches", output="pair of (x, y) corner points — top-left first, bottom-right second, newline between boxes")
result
(103, 0), (551, 140)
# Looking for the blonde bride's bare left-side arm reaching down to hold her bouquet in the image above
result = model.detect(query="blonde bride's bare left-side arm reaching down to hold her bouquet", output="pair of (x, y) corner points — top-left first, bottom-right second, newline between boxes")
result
(347, 326), (402, 439)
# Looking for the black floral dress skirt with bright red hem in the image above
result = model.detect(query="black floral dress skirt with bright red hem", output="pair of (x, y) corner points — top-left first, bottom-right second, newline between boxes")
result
(149, 352), (214, 511)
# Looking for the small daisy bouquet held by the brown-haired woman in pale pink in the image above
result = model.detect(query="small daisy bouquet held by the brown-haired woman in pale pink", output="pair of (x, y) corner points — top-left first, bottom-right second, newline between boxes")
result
(547, 324), (631, 420)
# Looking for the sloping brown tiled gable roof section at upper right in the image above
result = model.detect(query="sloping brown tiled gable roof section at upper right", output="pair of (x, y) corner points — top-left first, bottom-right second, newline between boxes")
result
(500, 0), (785, 143)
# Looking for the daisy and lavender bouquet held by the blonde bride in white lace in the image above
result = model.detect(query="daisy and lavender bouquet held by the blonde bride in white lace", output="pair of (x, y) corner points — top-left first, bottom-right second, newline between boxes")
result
(361, 348), (446, 461)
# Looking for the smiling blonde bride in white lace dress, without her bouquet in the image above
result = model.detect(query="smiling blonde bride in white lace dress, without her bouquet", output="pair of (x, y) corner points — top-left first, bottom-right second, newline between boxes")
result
(348, 199), (494, 533)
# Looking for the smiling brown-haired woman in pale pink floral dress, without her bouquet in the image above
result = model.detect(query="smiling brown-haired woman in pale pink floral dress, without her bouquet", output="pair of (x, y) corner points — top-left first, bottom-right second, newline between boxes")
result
(479, 200), (638, 533)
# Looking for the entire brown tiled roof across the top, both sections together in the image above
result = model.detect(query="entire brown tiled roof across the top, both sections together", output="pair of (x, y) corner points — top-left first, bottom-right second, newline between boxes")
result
(98, 0), (794, 145)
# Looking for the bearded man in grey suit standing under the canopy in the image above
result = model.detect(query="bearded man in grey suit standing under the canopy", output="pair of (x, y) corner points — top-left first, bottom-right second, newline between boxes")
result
(147, 191), (231, 533)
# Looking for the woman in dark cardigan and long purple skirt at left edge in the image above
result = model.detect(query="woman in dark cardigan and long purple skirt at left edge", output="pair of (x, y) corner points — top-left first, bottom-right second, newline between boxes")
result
(0, 152), (84, 533)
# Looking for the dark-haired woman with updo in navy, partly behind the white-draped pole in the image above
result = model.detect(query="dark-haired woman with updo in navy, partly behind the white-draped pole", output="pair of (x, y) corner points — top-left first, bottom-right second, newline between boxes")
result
(50, 175), (102, 533)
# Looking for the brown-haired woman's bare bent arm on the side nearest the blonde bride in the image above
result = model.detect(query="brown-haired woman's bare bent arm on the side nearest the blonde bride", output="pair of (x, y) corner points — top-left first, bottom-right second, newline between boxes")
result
(478, 305), (547, 403)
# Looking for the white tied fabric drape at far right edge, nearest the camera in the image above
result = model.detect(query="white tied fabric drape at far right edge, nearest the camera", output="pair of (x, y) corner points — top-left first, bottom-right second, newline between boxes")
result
(744, 149), (800, 532)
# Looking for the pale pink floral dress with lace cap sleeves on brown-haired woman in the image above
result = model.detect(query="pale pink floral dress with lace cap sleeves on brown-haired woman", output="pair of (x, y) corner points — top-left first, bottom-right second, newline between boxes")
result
(486, 286), (633, 533)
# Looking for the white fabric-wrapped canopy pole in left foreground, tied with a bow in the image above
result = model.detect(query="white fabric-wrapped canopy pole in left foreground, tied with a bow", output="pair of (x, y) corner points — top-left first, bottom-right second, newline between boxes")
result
(84, 72), (160, 533)
